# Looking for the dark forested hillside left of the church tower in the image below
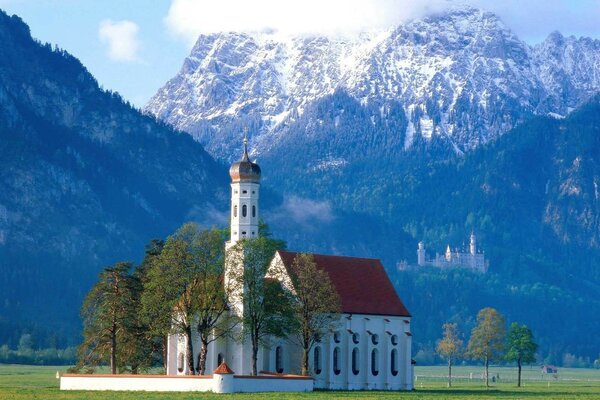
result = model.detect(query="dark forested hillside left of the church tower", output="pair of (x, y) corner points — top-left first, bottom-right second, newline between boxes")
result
(0, 12), (228, 347)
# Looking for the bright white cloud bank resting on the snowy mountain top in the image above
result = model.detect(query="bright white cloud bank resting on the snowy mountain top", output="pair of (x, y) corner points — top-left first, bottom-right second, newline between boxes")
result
(165, 0), (447, 42)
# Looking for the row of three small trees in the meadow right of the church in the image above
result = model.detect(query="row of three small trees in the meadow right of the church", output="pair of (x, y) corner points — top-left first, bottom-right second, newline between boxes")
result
(437, 307), (538, 387)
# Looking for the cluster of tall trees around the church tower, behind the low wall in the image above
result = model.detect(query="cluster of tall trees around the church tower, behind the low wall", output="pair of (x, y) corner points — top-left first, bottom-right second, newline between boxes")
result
(77, 223), (340, 375)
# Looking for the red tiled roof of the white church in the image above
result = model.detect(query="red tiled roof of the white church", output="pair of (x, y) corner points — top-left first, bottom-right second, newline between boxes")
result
(278, 251), (410, 317)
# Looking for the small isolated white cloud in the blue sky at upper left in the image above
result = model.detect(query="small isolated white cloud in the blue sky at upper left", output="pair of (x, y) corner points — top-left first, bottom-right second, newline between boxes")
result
(98, 19), (140, 62)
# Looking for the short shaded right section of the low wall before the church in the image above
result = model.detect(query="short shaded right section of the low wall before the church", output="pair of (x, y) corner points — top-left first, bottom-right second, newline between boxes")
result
(233, 375), (314, 393)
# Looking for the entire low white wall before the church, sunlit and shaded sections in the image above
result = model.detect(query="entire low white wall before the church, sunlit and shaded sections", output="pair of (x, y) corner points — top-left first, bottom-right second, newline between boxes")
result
(60, 374), (313, 393)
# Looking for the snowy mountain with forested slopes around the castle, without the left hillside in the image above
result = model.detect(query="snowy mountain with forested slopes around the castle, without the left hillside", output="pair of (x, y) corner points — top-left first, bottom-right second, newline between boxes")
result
(144, 8), (600, 362)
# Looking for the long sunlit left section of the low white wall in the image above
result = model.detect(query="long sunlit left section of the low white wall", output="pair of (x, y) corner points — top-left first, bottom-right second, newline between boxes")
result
(60, 374), (213, 392)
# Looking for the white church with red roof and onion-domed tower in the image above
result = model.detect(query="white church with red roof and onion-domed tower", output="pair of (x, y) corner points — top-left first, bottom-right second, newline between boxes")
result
(167, 139), (413, 390)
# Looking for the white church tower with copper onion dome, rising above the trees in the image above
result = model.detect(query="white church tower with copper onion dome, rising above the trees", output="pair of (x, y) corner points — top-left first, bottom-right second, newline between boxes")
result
(228, 130), (260, 246)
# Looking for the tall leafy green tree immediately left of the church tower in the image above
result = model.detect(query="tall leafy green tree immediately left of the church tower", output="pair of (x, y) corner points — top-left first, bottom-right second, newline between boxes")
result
(142, 223), (233, 374)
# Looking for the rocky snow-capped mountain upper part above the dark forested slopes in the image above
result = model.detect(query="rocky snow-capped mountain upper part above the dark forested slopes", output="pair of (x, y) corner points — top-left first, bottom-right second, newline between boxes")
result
(146, 8), (600, 160)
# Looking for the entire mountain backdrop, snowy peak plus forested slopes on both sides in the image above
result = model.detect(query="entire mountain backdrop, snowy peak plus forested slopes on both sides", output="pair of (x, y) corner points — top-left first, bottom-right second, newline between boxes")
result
(0, 9), (600, 363)
